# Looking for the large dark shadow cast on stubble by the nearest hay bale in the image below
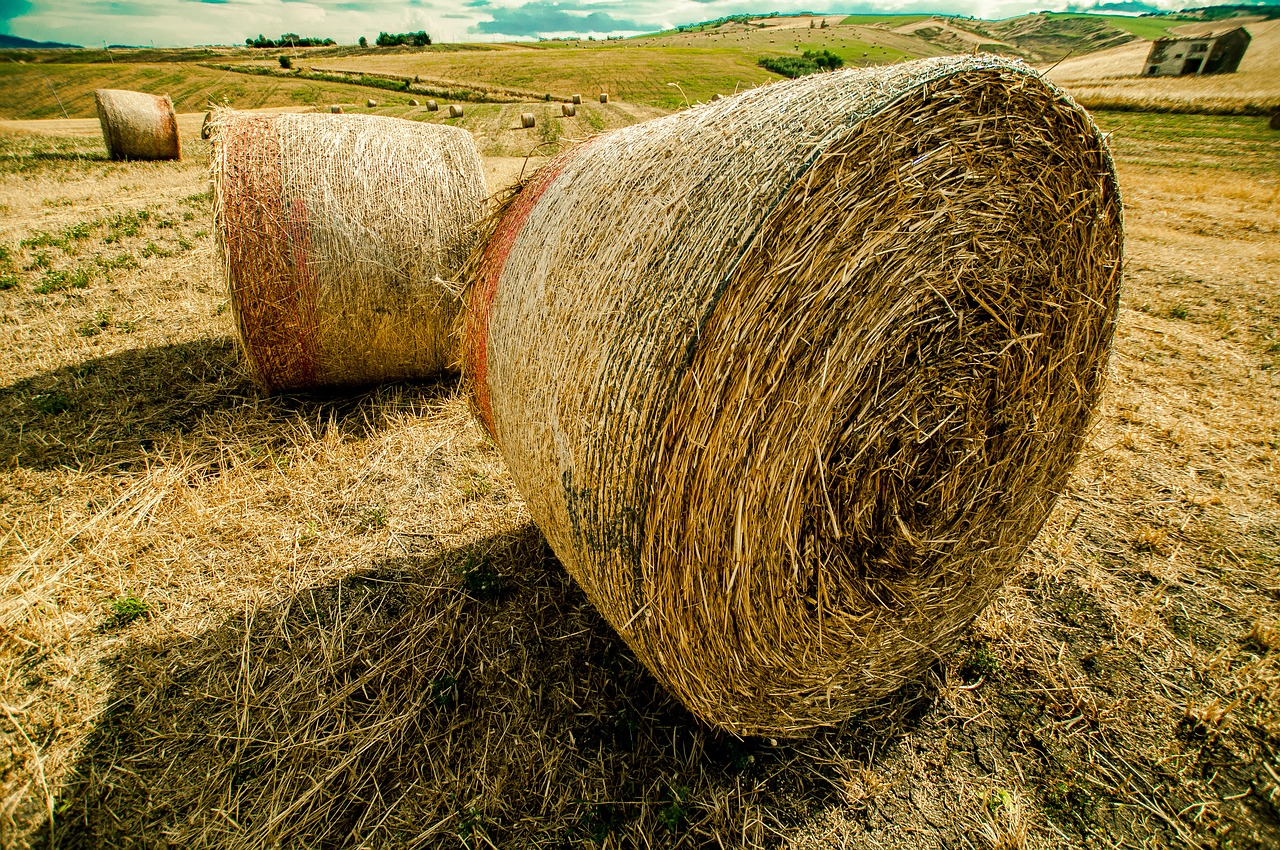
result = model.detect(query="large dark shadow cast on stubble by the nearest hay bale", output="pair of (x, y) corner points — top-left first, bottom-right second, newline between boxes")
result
(36, 525), (931, 847)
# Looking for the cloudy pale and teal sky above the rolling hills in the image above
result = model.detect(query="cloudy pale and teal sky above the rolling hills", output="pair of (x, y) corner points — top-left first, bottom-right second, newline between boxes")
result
(0, 0), (1233, 47)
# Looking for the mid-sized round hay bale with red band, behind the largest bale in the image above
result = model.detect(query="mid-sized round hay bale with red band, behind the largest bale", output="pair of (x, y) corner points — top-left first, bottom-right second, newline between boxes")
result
(211, 113), (485, 392)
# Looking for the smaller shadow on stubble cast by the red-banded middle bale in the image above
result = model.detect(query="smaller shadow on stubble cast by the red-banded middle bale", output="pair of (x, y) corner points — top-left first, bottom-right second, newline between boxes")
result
(0, 337), (452, 470)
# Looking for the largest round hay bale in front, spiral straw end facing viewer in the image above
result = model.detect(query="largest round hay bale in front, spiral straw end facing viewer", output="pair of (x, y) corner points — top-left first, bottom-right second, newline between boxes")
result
(463, 56), (1123, 734)
